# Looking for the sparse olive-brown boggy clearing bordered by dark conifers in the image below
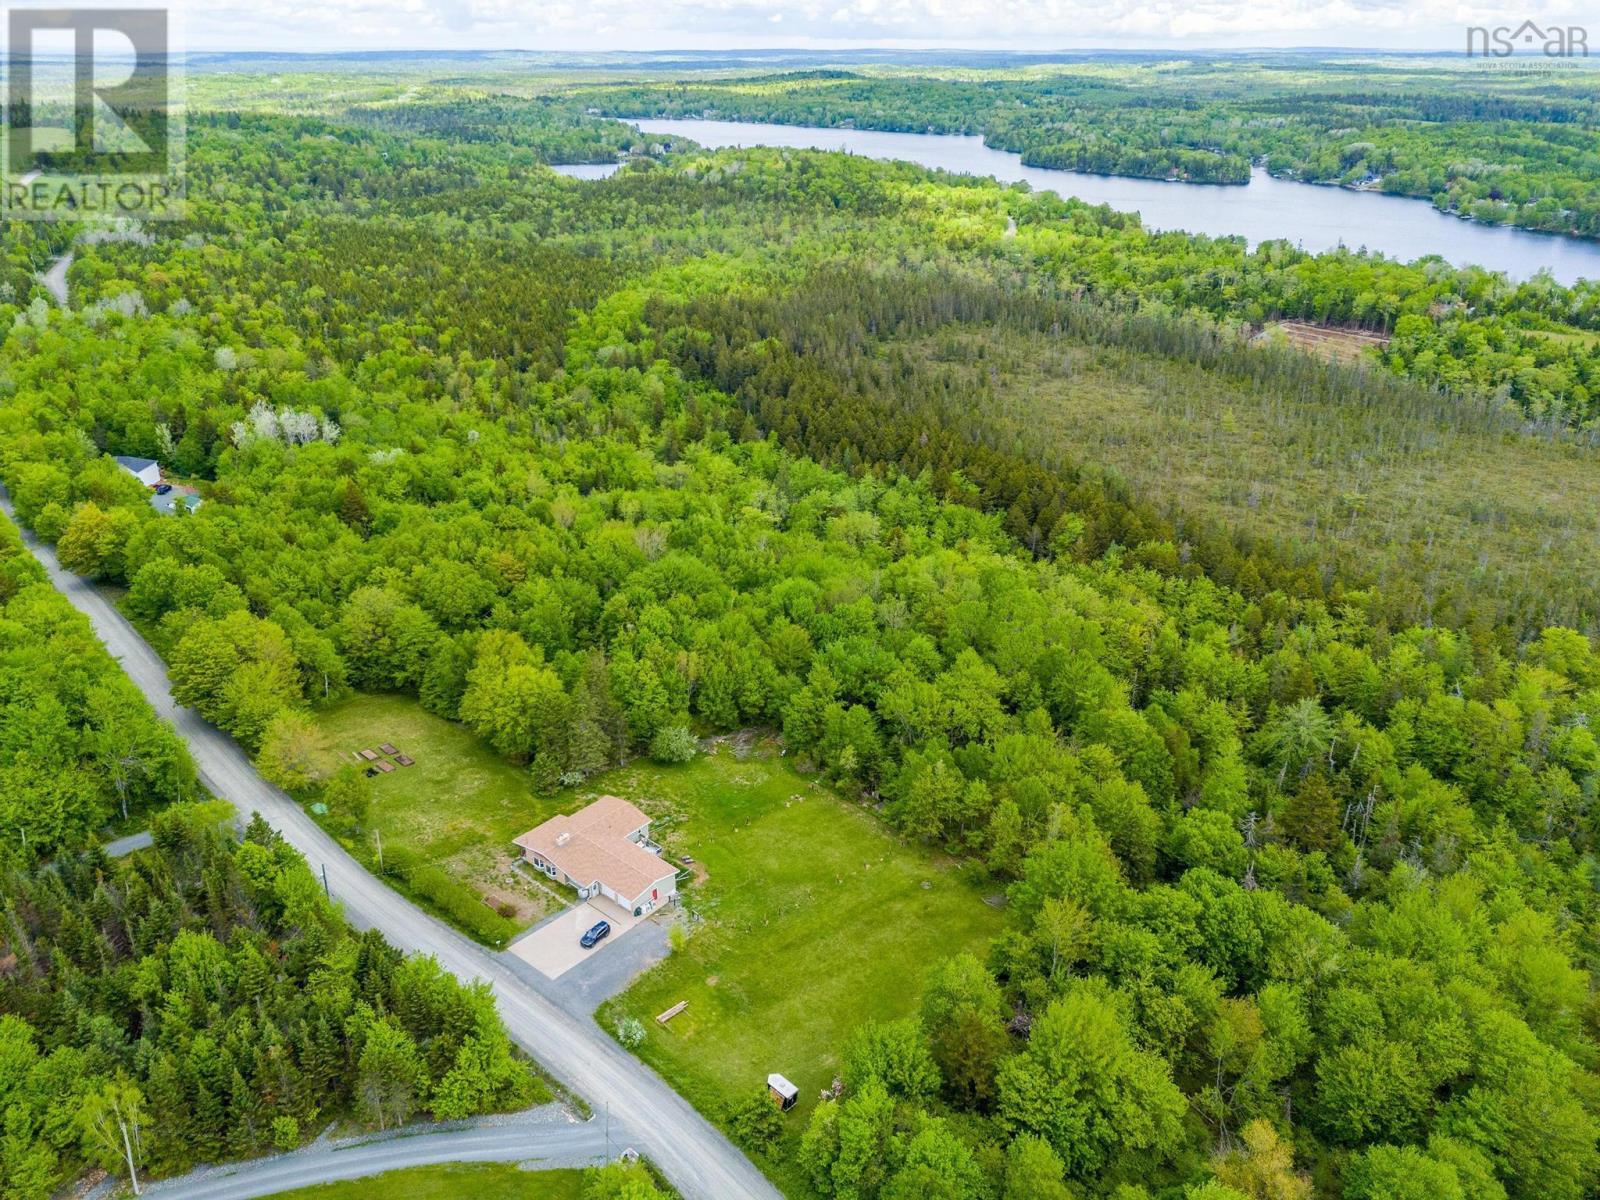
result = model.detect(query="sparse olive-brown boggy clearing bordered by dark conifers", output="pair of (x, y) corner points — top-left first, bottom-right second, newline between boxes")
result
(922, 331), (1600, 624)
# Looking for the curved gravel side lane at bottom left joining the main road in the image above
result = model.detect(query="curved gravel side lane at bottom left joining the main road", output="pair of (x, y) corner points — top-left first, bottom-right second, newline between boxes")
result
(128, 1104), (604, 1200)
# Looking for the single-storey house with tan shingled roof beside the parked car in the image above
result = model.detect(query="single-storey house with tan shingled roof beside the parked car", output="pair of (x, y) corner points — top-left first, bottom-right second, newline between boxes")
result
(515, 795), (678, 917)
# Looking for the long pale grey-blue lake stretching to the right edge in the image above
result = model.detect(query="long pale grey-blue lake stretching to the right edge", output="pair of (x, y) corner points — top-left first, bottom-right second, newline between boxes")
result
(629, 118), (1600, 283)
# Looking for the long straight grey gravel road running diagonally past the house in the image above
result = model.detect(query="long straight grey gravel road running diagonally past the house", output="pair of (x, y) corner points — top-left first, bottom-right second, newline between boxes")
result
(0, 490), (779, 1200)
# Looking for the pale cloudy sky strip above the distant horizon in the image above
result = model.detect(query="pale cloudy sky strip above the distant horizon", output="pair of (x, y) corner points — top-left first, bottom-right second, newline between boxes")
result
(134, 0), (1600, 53)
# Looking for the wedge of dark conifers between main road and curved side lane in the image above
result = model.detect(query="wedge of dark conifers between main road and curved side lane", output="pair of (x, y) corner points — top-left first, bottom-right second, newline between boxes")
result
(0, 805), (547, 1200)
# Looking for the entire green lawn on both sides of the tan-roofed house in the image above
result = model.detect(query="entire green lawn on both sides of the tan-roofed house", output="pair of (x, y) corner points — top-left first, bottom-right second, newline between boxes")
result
(322, 696), (1002, 1195)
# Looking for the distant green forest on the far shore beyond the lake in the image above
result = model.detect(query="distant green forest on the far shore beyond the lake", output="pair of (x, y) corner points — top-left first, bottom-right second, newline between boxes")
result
(573, 56), (1600, 237)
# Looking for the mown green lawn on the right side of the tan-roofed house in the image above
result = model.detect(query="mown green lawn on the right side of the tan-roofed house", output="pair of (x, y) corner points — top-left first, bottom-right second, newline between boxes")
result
(594, 747), (1002, 1195)
